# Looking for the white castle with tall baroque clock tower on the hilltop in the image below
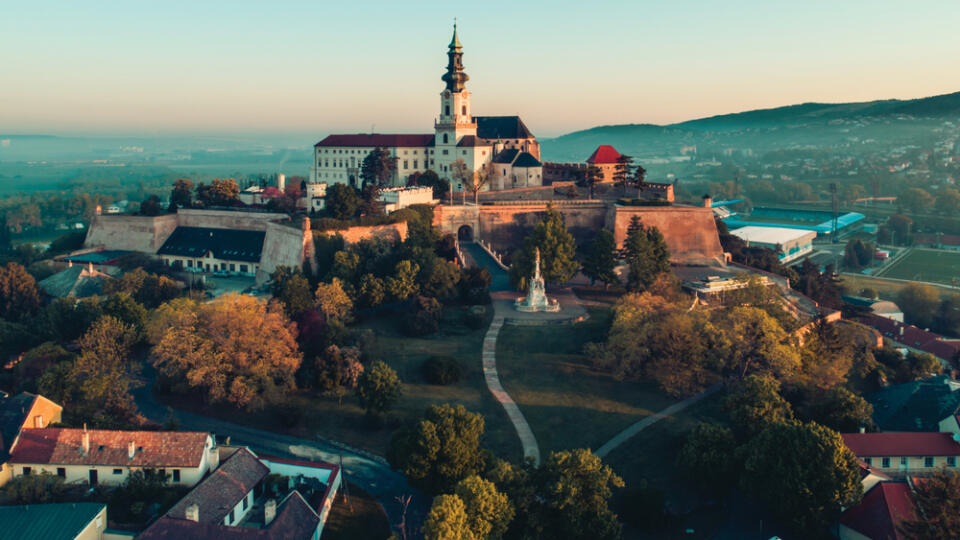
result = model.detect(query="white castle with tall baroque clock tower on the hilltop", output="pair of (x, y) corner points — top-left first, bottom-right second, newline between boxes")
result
(311, 25), (543, 191)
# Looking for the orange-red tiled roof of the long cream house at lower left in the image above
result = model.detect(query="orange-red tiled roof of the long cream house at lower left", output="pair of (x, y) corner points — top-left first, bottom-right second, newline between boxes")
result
(10, 428), (210, 467)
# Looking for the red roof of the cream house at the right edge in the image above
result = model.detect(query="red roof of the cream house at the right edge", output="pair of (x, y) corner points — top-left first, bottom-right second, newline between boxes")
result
(840, 432), (960, 457)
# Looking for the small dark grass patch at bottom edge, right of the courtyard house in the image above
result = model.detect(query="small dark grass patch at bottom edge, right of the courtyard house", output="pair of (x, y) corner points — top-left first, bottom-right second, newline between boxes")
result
(323, 483), (390, 540)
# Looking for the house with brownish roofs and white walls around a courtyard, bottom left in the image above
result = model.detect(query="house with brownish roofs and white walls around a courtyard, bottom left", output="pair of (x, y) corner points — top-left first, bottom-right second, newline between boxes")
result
(138, 448), (340, 540)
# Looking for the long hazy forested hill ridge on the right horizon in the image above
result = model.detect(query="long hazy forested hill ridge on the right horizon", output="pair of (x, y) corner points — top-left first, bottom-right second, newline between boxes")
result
(541, 92), (960, 162)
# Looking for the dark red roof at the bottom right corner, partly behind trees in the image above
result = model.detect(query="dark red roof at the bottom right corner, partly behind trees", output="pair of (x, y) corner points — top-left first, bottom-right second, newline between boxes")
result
(840, 482), (917, 540)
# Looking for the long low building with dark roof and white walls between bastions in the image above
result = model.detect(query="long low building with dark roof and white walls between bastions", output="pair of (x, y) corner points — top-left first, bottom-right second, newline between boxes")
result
(157, 227), (266, 276)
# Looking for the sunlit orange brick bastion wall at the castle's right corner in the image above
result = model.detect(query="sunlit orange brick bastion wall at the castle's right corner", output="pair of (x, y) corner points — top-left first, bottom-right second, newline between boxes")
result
(606, 206), (724, 265)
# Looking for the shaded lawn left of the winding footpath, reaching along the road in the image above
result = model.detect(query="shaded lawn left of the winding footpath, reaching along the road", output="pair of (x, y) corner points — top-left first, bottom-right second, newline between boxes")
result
(159, 306), (522, 460)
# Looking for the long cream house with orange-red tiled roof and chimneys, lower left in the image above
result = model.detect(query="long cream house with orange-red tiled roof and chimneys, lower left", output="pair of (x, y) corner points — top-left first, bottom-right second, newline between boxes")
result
(10, 427), (220, 487)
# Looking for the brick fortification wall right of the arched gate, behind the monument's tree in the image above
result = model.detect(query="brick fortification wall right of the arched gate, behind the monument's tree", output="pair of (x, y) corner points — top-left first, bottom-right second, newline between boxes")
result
(479, 201), (607, 253)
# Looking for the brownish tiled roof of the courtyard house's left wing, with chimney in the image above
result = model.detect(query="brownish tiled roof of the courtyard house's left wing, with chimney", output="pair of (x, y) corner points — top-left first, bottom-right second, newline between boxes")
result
(167, 448), (270, 523)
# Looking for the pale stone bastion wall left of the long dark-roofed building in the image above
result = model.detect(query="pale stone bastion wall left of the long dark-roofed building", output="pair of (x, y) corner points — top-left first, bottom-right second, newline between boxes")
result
(83, 214), (177, 253)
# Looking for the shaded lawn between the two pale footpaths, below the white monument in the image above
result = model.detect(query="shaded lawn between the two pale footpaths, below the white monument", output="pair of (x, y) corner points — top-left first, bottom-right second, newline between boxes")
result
(497, 307), (675, 455)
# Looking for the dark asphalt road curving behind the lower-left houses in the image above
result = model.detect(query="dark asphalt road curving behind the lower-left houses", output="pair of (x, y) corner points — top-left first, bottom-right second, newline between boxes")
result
(132, 365), (430, 538)
